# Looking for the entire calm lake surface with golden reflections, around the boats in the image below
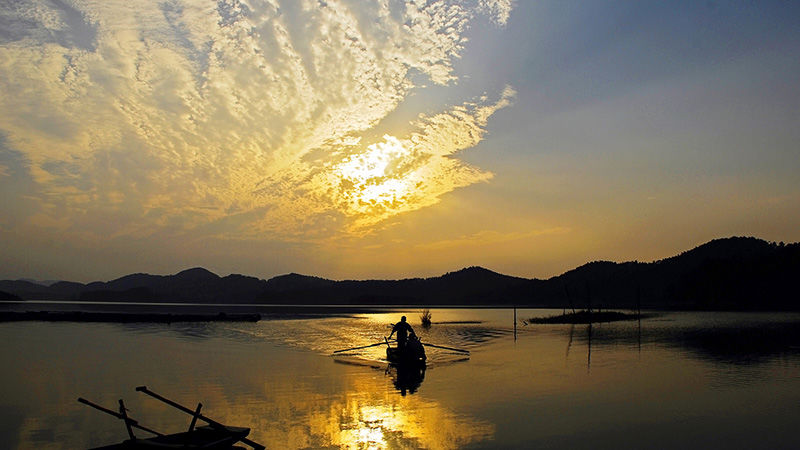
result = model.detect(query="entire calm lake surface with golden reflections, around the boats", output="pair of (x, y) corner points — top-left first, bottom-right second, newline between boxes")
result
(0, 309), (800, 449)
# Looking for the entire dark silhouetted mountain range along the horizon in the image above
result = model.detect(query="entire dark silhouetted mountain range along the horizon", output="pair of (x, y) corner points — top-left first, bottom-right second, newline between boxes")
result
(0, 237), (800, 310)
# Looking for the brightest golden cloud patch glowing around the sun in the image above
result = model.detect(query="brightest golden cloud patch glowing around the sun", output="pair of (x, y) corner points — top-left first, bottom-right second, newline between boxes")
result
(245, 87), (515, 235)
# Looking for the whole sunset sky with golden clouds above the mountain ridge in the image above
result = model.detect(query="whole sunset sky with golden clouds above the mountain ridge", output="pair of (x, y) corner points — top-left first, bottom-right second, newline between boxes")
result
(0, 0), (800, 282)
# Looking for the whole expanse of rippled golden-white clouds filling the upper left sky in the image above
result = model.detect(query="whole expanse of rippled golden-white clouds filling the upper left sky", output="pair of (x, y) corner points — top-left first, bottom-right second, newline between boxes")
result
(0, 0), (513, 243)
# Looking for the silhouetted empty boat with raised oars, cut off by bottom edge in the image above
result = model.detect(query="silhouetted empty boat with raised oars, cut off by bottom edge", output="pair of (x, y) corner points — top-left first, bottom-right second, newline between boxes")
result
(78, 386), (264, 450)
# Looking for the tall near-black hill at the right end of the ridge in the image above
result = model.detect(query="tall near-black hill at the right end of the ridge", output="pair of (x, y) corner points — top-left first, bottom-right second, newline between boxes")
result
(534, 237), (800, 310)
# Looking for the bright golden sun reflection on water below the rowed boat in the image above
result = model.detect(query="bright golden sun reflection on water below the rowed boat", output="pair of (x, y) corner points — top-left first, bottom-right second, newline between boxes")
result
(252, 368), (494, 448)
